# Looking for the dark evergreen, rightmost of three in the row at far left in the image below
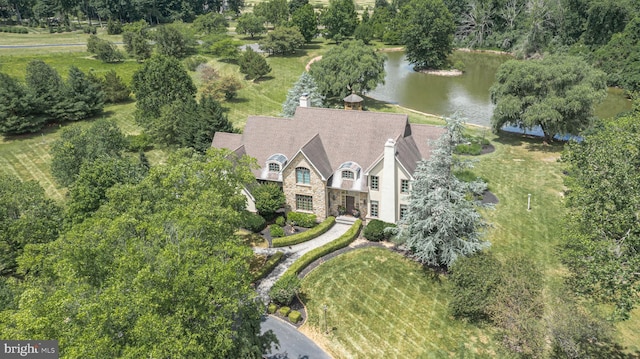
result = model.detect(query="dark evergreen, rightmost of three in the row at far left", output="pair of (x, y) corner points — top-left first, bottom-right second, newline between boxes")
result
(55, 66), (104, 121)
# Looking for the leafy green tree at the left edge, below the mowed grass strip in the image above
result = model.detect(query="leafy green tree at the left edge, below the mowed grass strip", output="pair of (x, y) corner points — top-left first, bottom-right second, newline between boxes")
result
(0, 174), (62, 278)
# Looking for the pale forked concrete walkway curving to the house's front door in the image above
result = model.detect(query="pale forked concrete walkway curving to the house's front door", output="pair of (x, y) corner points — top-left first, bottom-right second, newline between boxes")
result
(253, 223), (351, 304)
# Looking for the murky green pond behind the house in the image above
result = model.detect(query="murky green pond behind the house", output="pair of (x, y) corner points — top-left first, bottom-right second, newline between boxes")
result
(367, 51), (631, 130)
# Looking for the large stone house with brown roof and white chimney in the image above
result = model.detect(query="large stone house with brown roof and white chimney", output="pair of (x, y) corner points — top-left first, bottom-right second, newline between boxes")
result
(212, 100), (445, 223)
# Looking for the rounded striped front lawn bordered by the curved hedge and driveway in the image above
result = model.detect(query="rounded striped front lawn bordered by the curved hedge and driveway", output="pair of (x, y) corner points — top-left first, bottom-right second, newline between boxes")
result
(302, 248), (497, 358)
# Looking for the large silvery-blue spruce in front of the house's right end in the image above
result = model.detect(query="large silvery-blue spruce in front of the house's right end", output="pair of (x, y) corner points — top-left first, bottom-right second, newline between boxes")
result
(400, 118), (489, 268)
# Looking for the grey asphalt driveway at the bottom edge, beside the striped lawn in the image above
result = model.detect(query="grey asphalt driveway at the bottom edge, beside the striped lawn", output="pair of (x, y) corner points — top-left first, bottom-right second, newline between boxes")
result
(261, 316), (331, 359)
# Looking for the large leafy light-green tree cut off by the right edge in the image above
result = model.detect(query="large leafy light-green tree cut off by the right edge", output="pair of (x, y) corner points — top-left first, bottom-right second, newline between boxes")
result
(562, 112), (640, 319)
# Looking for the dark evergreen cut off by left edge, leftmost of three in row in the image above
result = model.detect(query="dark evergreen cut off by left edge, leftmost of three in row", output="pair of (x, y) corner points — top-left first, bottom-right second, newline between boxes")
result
(0, 73), (46, 135)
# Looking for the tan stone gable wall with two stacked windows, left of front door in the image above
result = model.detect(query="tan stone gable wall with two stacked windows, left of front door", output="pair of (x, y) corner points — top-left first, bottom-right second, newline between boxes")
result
(282, 152), (328, 220)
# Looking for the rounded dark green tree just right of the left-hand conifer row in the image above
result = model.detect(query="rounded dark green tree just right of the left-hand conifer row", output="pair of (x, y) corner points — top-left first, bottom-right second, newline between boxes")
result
(131, 55), (196, 131)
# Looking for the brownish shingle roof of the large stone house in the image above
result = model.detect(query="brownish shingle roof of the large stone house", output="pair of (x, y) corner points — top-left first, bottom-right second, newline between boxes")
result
(212, 107), (444, 179)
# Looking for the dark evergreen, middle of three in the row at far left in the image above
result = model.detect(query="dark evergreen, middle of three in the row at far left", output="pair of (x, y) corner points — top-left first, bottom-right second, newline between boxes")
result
(25, 60), (63, 119)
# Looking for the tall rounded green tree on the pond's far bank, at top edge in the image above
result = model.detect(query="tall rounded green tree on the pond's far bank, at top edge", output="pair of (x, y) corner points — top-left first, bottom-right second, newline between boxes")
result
(399, 0), (456, 70)
